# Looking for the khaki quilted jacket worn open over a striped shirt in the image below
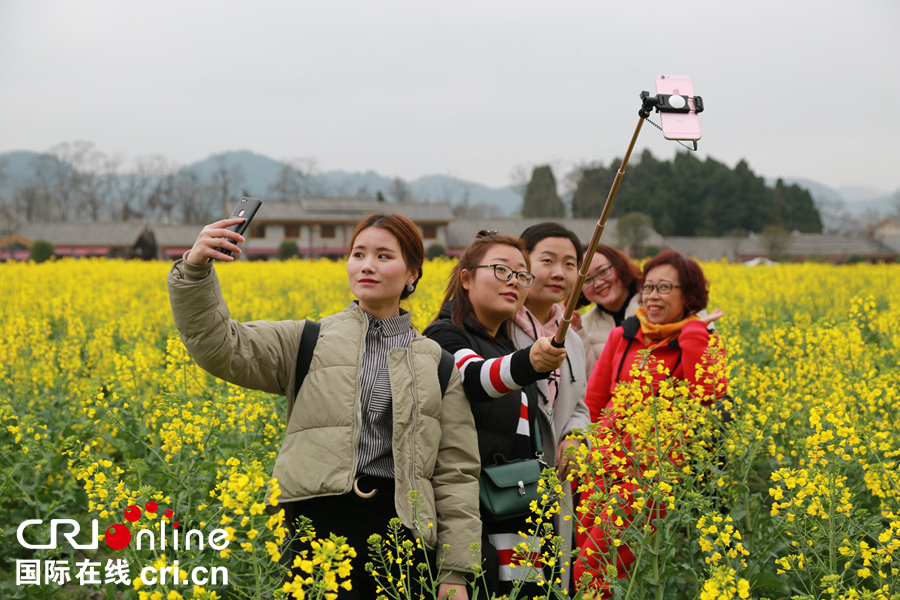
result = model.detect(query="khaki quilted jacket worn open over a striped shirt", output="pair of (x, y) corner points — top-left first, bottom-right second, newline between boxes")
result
(168, 259), (481, 583)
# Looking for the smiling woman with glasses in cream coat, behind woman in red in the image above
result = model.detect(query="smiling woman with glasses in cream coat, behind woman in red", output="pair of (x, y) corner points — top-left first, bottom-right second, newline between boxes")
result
(572, 244), (641, 377)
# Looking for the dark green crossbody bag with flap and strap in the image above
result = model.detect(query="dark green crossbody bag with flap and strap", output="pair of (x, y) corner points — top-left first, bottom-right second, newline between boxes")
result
(478, 423), (549, 521)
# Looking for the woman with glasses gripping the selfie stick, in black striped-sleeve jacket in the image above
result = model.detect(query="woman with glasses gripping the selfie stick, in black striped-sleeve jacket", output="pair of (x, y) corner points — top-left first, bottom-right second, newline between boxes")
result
(425, 231), (566, 598)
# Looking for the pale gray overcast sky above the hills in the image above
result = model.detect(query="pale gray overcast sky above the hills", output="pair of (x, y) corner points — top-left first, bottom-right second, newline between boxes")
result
(0, 0), (900, 192)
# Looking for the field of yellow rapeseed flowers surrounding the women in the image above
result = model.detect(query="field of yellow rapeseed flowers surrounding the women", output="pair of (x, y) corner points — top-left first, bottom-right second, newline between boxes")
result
(0, 259), (900, 600)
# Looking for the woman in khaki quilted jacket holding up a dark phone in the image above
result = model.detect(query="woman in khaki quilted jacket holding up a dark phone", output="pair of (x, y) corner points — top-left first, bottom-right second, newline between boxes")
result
(168, 215), (481, 600)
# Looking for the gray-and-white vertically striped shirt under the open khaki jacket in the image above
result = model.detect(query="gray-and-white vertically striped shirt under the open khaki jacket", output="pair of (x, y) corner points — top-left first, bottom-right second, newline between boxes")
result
(352, 300), (416, 478)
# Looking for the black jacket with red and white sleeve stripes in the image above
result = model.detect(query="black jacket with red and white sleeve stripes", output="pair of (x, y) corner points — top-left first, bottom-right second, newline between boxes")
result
(423, 302), (553, 466)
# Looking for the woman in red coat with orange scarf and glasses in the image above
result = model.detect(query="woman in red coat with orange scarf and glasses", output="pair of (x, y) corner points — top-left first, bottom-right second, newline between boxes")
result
(574, 251), (725, 589)
